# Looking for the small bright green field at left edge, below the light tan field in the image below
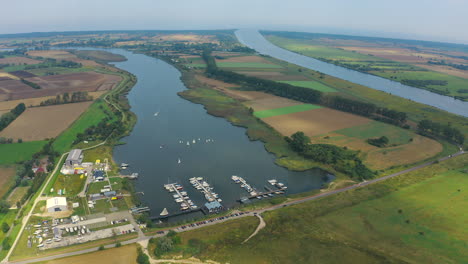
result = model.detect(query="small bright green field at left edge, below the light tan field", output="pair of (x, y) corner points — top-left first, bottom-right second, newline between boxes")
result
(0, 140), (47, 165)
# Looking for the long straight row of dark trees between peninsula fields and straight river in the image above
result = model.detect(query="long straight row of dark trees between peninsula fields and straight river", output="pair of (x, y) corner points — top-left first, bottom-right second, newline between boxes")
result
(202, 50), (409, 128)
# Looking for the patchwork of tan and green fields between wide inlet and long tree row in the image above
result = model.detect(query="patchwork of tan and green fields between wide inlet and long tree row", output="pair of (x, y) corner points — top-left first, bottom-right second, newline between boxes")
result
(244, 91), (444, 170)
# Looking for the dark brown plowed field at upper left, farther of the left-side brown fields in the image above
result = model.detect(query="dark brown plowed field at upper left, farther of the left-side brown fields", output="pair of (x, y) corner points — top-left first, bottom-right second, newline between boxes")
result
(0, 72), (121, 101)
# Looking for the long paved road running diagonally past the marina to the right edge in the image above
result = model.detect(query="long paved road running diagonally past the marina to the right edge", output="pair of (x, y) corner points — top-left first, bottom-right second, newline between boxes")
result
(5, 150), (466, 264)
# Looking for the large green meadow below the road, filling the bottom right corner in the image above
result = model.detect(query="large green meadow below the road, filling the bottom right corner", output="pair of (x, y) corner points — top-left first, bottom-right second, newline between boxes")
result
(166, 155), (468, 264)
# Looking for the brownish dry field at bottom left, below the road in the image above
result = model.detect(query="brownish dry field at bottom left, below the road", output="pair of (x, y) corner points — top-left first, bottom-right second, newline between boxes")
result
(42, 244), (137, 264)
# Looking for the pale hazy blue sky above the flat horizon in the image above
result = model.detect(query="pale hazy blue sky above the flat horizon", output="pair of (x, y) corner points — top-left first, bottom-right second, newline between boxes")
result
(0, 0), (468, 44)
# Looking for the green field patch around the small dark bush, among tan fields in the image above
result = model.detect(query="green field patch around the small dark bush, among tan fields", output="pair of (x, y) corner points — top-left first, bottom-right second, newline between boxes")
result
(334, 121), (414, 145)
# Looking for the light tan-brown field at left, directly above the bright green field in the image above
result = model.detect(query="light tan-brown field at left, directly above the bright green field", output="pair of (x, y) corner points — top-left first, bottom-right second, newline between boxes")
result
(0, 102), (92, 141)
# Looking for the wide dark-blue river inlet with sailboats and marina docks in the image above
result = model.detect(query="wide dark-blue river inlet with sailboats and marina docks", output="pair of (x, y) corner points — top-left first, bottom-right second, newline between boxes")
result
(76, 49), (332, 221)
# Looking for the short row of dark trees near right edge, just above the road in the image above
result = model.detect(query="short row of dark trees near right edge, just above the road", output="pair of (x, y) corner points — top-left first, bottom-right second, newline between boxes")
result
(418, 119), (465, 145)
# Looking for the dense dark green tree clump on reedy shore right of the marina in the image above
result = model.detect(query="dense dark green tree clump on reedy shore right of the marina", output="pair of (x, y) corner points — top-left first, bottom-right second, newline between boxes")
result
(285, 131), (374, 180)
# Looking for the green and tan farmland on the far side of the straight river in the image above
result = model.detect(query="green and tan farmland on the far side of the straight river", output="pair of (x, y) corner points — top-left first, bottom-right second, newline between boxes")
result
(266, 33), (468, 98)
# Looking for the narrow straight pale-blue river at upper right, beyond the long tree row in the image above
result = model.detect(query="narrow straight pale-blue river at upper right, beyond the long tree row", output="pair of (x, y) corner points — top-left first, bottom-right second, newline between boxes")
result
(236, 29), (468, 117)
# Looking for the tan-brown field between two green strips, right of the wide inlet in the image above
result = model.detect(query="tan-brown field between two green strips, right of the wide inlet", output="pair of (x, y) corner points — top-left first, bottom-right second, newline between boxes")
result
(262, 108), (370, 137)
